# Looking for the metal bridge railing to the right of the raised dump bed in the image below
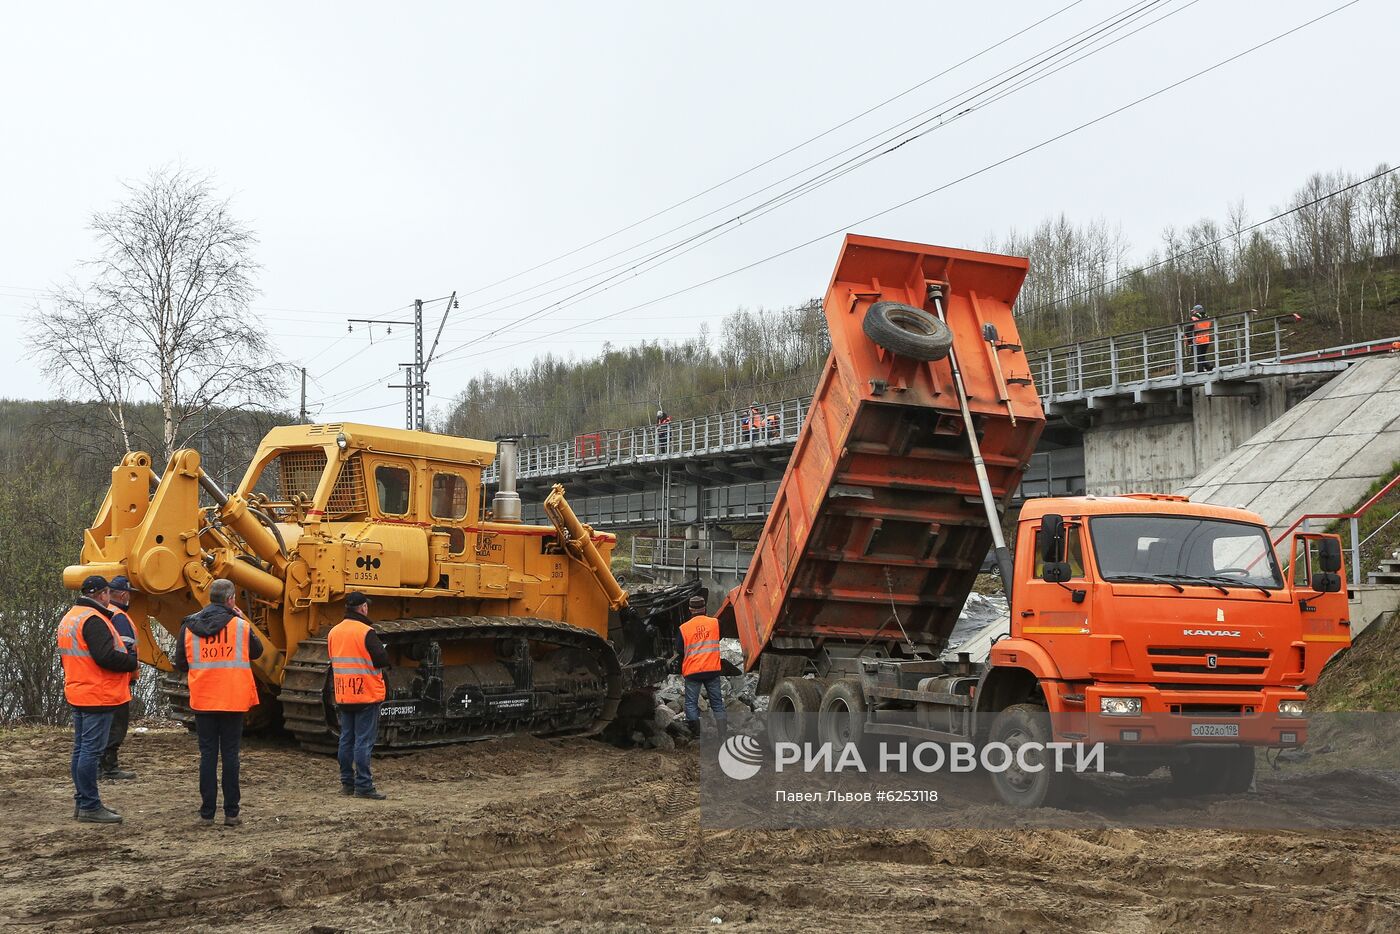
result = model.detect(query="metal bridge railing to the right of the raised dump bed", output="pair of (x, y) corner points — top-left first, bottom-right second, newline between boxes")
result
(1026, 311), (1292, 398)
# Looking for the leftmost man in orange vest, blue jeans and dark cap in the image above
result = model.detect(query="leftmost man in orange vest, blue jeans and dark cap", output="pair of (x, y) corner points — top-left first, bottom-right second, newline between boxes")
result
(57, 574), (136, 823)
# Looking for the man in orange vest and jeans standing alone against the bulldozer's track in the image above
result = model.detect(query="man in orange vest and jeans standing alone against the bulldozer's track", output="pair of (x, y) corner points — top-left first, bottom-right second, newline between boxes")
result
(326, 591), (389, 801)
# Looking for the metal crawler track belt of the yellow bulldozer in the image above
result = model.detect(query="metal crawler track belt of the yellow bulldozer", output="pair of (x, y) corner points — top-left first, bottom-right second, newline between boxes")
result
(279, 616), (624, 753)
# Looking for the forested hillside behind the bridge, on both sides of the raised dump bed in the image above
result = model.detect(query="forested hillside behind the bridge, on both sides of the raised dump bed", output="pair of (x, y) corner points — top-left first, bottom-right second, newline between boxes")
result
(442, 165), (1400, 440)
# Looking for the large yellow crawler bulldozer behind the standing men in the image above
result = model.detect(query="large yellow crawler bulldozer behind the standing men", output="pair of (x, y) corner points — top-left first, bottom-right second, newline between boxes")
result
(63, 424), (700, 751)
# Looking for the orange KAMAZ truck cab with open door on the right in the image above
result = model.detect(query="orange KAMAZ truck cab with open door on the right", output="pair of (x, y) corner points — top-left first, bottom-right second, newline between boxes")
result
(988, 494), (1351, 745)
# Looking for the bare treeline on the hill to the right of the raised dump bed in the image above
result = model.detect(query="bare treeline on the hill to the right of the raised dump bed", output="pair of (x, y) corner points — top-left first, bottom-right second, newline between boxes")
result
(990, 165), (1400, 347)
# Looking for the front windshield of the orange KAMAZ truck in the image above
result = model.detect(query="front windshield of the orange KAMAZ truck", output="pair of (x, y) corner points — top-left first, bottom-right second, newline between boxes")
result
(1089, 515), (1282, 590)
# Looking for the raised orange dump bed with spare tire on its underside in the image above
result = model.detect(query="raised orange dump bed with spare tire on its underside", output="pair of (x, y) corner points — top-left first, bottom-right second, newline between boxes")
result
(720, 235), (1044, 680)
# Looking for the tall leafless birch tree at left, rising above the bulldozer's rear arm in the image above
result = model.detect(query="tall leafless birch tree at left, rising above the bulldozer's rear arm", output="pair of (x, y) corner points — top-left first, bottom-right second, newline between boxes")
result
(31, 169), (287, 458)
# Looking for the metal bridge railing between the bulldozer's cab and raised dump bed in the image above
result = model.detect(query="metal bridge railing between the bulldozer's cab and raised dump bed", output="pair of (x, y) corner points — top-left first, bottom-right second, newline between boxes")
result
(483, 396), (812, 483)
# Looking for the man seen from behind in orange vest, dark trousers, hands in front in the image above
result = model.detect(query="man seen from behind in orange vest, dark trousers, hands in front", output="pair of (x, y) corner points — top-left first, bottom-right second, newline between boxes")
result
(175, 578), (262, 828)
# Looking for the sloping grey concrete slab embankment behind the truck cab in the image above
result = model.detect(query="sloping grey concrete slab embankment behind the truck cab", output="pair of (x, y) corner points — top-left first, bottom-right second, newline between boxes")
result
(1177, 357), (1400, 536)
